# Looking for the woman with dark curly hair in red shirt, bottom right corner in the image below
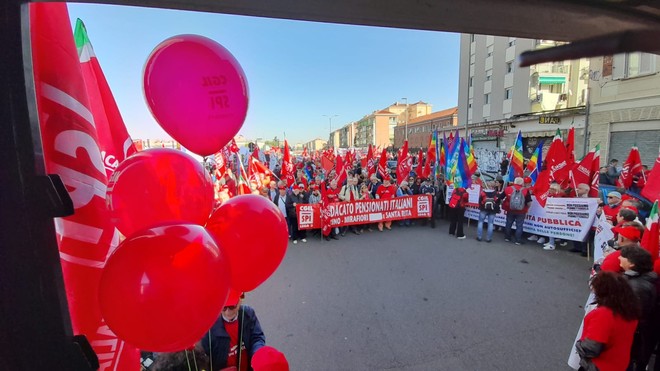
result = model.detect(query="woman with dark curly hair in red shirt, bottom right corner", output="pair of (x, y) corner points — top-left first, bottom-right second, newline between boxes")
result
(575, 271), (639, 371)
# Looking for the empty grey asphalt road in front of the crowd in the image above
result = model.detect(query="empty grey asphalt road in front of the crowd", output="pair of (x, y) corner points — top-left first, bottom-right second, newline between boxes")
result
(246, 221), (590, 371)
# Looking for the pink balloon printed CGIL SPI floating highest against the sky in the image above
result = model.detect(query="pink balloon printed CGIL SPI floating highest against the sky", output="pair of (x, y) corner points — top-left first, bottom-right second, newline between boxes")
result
(144, 35), (248, 156)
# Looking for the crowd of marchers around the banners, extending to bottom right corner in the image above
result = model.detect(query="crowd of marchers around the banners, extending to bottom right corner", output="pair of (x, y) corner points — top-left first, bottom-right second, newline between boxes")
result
(205, 150), (660, 371)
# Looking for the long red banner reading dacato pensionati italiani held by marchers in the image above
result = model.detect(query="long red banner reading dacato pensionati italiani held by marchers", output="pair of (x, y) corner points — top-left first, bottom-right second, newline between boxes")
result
(296, 195), (432, 229)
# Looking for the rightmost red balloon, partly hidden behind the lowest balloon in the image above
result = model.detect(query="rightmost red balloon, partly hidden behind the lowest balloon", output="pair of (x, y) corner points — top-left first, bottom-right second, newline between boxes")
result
(206, 195), (289, 291)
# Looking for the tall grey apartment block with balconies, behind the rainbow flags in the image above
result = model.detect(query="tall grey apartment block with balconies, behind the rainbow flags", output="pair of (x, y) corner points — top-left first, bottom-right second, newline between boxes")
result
(458, 34), (589, 172)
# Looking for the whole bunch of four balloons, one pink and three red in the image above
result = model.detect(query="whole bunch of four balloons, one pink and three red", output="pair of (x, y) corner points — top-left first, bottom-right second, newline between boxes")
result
(99, 35), (288, 352)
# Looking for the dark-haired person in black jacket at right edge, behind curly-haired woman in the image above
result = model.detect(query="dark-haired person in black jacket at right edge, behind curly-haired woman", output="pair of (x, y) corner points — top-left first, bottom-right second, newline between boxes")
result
(619, 246), (657, 371)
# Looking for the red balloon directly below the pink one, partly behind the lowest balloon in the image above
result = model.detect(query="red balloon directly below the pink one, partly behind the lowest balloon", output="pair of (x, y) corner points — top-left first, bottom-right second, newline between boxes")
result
(106, 148), (214, 237)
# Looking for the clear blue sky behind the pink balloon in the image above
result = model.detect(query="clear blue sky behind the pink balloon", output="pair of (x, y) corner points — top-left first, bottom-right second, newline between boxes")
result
(68, 4), (459, 143)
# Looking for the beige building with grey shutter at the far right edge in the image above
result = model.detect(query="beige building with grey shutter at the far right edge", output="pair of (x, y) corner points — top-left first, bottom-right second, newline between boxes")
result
(588, 53), (660, 167)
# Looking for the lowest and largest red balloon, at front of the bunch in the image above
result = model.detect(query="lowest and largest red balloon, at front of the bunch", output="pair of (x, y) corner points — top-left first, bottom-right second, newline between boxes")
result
(99, 224), (229, 352)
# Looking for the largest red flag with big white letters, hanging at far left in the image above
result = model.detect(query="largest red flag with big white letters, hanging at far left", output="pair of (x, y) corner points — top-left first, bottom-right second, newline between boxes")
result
(29, 3), (140, 371)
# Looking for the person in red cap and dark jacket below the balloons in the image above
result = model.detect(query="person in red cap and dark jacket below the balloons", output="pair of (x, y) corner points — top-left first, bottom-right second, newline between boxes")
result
(201, 290), (266, 371)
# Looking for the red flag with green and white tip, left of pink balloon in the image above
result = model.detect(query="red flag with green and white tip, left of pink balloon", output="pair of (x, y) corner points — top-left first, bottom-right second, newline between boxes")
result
(74, 19), (137, 177)
